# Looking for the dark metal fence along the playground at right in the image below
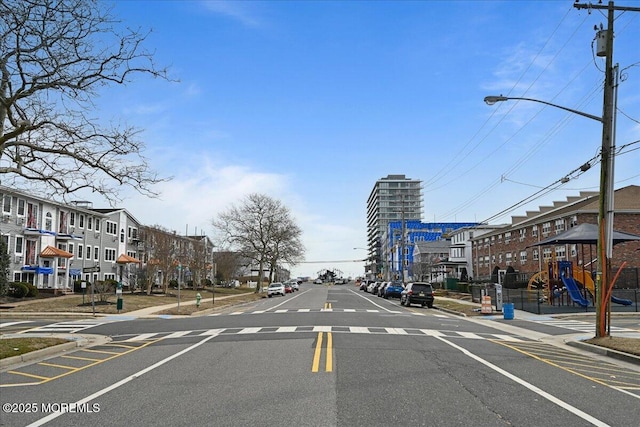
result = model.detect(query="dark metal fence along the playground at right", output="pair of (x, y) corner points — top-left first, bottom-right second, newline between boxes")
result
(469, 285), (640, 314)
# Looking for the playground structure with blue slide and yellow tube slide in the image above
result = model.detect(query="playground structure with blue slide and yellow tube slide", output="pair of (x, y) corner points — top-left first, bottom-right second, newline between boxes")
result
(528, 260), (633, 307)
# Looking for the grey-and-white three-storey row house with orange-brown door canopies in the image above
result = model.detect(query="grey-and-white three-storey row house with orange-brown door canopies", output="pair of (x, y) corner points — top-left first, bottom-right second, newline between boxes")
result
(0, 186), (139, 291)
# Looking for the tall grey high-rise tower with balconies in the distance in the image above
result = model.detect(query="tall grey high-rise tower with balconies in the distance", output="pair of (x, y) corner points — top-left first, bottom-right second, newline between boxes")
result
(366, 175), (422, 276)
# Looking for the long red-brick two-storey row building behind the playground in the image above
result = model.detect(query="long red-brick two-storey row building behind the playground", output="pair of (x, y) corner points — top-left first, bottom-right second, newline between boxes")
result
(470, 185), (640, 280)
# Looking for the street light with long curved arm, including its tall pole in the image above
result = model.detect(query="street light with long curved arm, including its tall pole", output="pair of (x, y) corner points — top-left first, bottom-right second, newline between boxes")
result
(484, 89), (618, 337)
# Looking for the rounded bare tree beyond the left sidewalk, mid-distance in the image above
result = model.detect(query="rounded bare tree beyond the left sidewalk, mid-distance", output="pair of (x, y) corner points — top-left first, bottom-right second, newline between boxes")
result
(212, 193), (304, 292)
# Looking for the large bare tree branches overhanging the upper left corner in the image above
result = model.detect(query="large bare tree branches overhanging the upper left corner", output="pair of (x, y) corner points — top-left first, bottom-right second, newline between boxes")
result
(0, 0), (167, 203)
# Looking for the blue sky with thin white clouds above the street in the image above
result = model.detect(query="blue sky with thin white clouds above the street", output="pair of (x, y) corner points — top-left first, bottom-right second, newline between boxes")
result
(89, 0), (640, 276)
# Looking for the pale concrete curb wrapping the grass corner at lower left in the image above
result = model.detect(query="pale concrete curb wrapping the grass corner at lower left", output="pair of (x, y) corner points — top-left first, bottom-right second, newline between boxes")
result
(0, 334), (111, 370)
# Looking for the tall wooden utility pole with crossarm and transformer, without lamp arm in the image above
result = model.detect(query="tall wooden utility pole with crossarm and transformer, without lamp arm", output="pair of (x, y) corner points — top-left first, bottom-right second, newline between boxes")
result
(574, 1), (640, 337)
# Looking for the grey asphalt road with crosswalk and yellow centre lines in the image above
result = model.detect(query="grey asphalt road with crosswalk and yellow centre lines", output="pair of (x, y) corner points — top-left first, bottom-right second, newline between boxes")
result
(0, 285), (640, 427)
